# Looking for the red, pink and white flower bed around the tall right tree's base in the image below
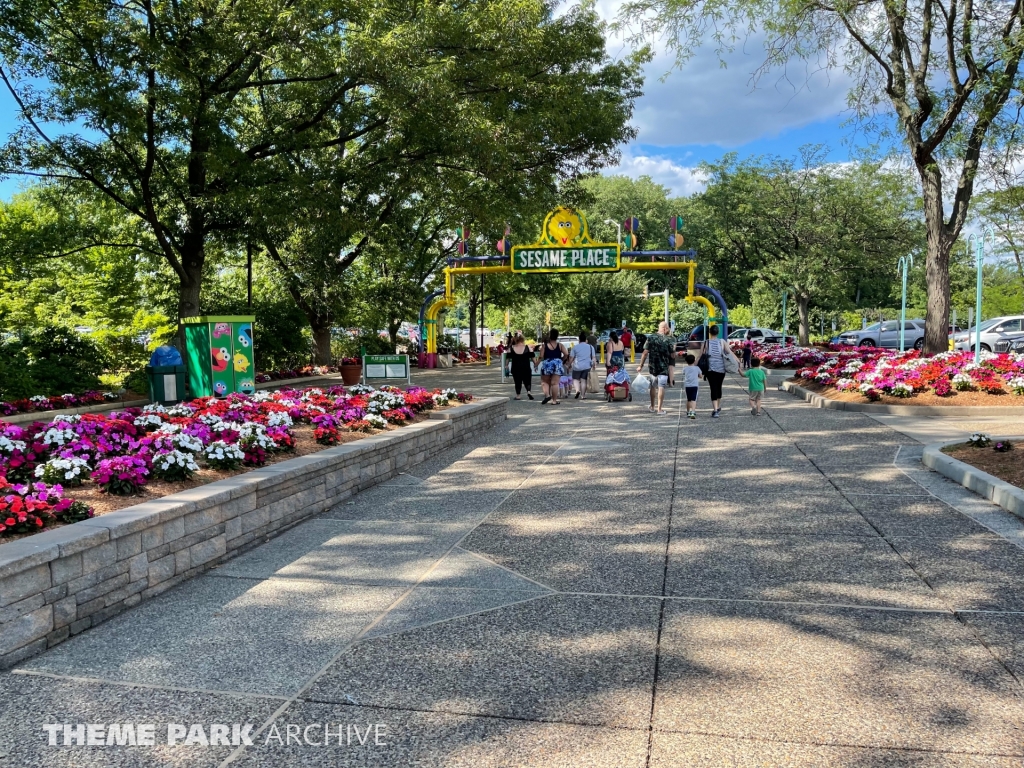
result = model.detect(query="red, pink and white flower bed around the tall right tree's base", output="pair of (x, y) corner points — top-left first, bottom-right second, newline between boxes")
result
(782, 348), (1024, 406)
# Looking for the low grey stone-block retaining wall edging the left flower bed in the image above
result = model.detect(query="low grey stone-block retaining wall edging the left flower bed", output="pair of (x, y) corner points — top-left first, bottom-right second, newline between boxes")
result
(0, 397), (508, 669)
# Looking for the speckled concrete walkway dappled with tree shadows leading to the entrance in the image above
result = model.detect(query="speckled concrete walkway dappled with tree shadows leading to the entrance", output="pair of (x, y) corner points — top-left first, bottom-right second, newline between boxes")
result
(0, 369), (1024, 768)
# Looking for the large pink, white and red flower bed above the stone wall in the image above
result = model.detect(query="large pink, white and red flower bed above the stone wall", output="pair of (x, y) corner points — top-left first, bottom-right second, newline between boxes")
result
(0, 385), (472, 540)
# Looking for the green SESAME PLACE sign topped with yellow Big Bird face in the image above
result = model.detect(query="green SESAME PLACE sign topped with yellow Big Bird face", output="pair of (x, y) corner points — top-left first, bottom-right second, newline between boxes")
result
(512, 208), (620, 272)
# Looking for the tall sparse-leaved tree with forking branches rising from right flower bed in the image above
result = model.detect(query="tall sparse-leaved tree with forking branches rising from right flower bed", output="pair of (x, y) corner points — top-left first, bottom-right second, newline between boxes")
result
(620, 0), (1024, 354)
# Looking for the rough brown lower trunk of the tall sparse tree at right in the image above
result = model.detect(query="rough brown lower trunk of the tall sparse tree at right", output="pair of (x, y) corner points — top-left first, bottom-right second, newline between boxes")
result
(919, 161), (953, 355)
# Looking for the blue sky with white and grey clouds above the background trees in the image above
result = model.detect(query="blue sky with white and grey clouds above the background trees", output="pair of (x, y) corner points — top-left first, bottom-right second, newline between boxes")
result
(0, 12), (866, 198)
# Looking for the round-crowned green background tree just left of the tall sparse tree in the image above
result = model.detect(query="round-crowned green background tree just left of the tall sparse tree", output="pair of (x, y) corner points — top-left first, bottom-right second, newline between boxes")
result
(700, 147), (921, 344)
